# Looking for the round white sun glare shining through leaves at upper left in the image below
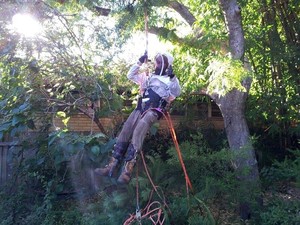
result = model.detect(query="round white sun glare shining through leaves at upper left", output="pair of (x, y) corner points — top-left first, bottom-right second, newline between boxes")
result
(12, 13), (42, 37)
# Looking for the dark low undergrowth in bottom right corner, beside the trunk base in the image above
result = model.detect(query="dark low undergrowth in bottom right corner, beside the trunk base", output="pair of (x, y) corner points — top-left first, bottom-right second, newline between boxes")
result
(257, 150), (300, 225)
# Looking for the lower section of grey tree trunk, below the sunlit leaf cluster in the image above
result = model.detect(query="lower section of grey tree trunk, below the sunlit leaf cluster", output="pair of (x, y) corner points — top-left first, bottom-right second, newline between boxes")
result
(217, 90), (260, 220)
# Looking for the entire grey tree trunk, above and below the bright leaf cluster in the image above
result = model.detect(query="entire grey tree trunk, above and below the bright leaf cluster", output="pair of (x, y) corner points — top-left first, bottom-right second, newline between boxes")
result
(216, 0), (260, 219)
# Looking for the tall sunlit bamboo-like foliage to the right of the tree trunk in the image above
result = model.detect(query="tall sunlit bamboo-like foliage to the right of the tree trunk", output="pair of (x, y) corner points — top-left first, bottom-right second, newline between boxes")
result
(243, 0), (300, 151)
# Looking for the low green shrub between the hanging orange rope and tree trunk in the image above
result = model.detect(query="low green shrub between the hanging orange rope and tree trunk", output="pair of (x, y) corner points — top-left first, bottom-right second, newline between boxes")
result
(168, 133), (235, 198)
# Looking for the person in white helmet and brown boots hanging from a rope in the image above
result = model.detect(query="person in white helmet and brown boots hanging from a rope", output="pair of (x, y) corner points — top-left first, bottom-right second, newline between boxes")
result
(95, 52), (181, 183)
